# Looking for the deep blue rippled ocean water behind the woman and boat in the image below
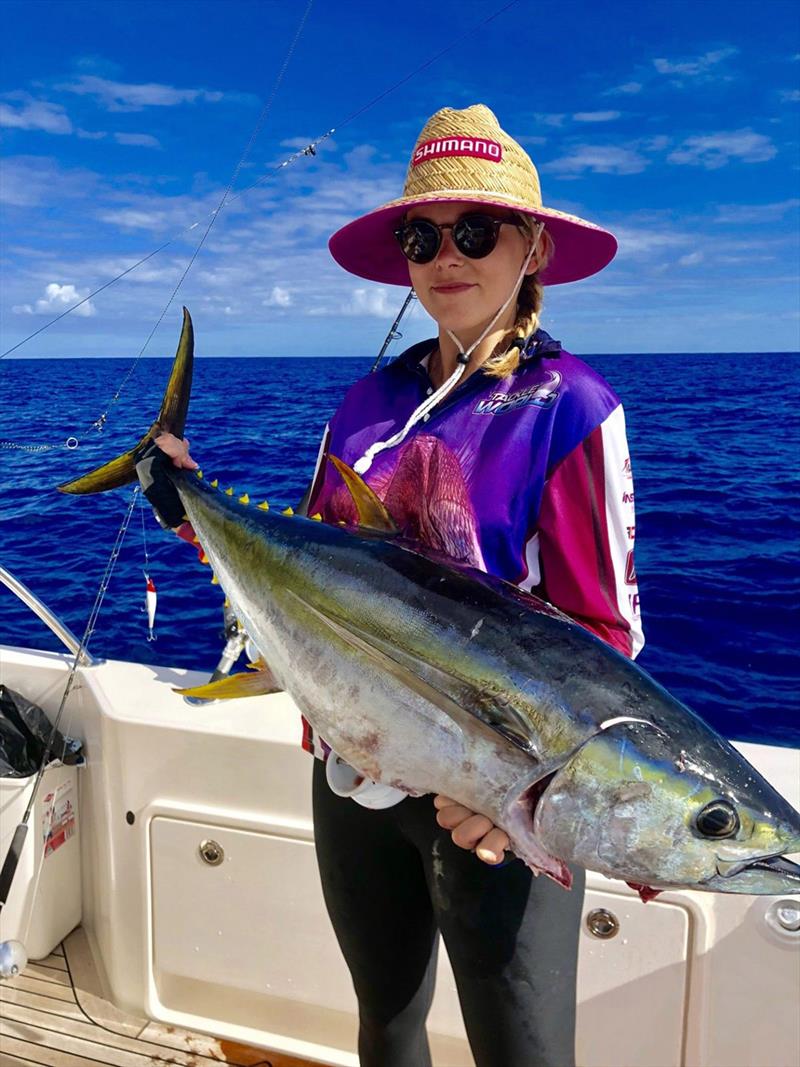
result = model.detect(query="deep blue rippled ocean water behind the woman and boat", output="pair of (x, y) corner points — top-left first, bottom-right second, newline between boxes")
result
(0, 353), (800, 745)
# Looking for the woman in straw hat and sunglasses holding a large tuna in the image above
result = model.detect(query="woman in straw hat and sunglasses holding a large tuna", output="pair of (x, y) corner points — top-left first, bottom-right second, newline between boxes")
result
(151, 105), (642, 1067)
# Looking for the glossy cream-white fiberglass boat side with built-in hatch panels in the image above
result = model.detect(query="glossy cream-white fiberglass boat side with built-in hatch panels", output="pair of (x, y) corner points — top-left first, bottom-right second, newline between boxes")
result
(0, 648), (800, 1067)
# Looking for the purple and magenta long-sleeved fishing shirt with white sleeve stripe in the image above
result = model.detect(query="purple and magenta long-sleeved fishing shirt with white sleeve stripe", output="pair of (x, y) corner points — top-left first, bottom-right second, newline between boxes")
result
(303, 330), (644, 758)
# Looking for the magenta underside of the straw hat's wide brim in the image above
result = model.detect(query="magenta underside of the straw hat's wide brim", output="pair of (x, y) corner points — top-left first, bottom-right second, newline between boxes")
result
(329, 196), (617, 287)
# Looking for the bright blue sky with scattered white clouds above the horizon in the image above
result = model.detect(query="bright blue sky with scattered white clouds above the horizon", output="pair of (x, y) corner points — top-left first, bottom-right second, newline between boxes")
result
(0, 0), (800, 356)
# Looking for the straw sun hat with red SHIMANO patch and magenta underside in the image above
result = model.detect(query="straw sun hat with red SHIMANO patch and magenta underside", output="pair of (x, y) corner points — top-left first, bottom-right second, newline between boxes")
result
(329, 103), (617, 286)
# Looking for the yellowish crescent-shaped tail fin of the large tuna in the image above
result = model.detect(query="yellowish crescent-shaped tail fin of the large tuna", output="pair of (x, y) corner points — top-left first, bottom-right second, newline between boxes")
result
(58, 307), (194, 494)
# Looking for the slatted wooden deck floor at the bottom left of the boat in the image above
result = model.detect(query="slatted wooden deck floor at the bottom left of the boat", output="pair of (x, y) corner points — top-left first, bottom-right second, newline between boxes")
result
(0, 935), (326, 1067)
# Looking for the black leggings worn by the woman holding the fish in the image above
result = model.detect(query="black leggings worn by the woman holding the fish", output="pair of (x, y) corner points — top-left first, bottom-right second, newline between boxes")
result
(314, 760), (585, 1067)
